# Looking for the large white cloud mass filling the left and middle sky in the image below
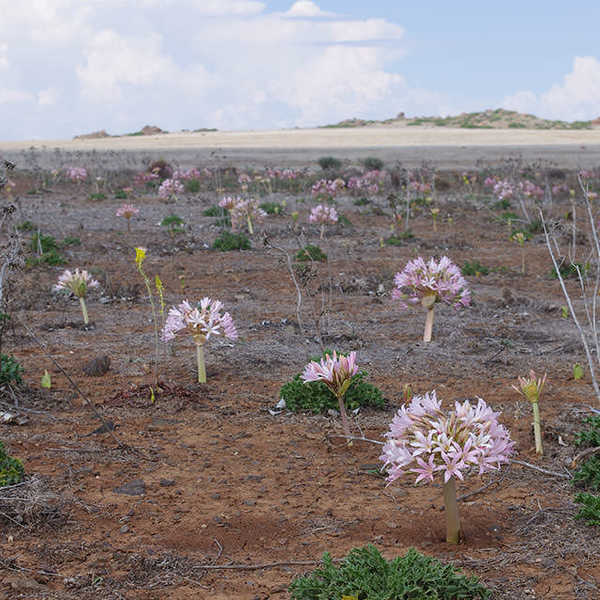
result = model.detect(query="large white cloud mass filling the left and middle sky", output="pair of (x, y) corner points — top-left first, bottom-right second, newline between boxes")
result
(0, 0), (454, 139)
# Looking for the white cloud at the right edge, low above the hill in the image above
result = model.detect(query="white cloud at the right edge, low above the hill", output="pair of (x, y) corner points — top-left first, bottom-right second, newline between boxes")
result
(503, 56), (600, 121)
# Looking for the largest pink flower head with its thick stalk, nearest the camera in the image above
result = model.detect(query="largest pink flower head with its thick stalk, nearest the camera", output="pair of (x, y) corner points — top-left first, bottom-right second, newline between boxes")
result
(380, 391), (514, 544)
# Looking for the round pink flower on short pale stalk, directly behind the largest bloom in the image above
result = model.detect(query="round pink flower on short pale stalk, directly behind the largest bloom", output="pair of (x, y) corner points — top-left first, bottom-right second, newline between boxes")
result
(392, 256), (471, 342)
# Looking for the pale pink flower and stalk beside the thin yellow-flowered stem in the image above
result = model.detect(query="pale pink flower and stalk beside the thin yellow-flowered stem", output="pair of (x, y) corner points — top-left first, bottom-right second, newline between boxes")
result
(162, 298), (238, 383)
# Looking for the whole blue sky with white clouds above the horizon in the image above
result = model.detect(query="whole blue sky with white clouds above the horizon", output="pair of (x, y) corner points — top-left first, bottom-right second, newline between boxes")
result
(0, 0), (600, 140)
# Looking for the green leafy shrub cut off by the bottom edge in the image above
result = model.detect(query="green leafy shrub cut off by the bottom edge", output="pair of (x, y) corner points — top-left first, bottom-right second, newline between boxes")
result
(290, 544), (491, 600)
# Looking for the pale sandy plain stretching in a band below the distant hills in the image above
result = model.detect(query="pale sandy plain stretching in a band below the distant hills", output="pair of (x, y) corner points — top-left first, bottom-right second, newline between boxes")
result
(0, 126), (600, 169)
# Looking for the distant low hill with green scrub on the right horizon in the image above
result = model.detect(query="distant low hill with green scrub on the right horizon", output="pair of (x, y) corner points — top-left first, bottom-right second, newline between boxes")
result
(323, 108), (600, 129)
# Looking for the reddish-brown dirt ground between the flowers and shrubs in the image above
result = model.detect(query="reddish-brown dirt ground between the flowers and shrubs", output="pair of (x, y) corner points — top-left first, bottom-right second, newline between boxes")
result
(0, 170), (600, 600)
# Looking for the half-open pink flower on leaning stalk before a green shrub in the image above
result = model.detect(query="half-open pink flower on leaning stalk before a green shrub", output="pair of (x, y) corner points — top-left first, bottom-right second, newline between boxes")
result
(302, 350), (358, 438)
